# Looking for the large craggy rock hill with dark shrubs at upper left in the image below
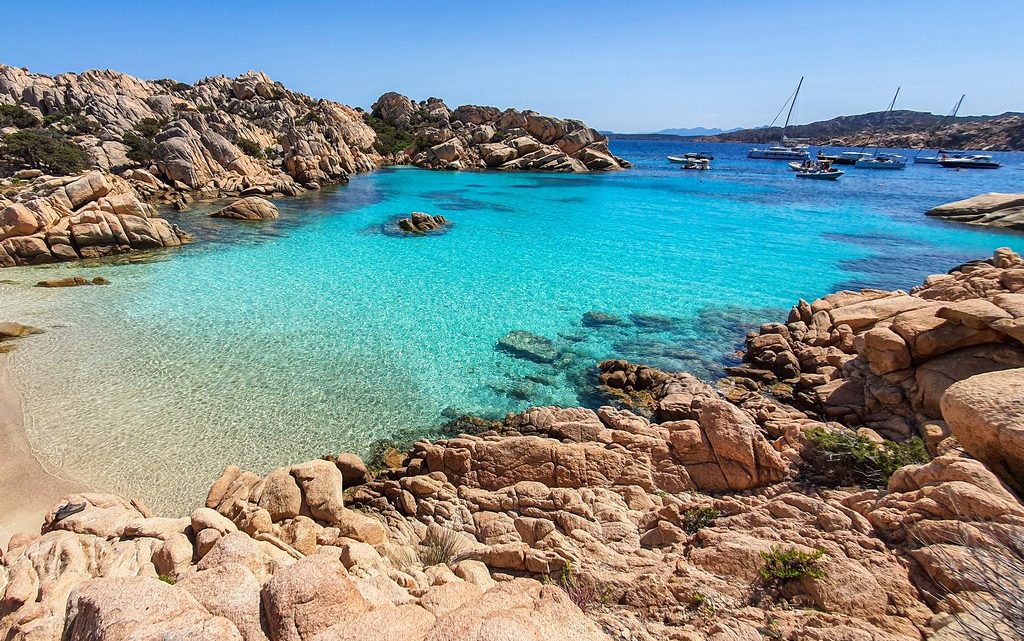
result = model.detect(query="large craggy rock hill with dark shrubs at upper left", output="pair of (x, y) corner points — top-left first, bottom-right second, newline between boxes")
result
(0, 65), (380, 201)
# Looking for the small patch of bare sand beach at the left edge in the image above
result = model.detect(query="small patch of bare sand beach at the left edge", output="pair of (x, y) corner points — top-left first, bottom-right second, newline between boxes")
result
(0, 354), (85, 550)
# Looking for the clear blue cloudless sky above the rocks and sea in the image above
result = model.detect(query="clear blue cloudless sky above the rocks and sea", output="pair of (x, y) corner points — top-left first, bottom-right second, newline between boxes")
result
(0, 0), (1024, 132)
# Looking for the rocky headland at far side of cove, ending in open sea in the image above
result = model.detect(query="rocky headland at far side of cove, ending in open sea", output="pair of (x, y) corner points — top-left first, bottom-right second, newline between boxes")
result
(373, 92), (629, 172)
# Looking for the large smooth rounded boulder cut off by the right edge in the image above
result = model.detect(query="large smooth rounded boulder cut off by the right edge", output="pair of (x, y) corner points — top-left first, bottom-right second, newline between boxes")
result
(941, 369), (1024, 496)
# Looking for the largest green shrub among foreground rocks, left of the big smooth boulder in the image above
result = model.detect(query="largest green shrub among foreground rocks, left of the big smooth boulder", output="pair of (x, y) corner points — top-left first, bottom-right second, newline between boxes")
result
(804, 427), (930, 487)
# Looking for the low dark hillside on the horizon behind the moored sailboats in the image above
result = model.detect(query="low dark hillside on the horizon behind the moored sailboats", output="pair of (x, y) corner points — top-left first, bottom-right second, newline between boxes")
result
(699, 110), (1024, 151)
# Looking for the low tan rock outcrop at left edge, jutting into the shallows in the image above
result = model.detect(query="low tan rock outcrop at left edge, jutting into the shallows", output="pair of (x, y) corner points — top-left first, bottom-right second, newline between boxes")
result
(0, 171), (189, 267)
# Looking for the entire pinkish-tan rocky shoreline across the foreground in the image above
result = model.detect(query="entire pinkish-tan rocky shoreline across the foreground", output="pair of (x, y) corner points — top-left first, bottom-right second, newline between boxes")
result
(0, 248), (1024, 641)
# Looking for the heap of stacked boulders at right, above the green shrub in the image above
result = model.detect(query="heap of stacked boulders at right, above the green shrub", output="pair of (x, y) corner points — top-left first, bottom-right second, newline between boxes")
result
(731, 248), (1024, 442)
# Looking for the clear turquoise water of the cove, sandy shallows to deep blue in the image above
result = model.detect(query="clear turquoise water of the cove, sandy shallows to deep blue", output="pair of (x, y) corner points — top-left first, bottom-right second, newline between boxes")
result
(0, 142), (1024, 510)
